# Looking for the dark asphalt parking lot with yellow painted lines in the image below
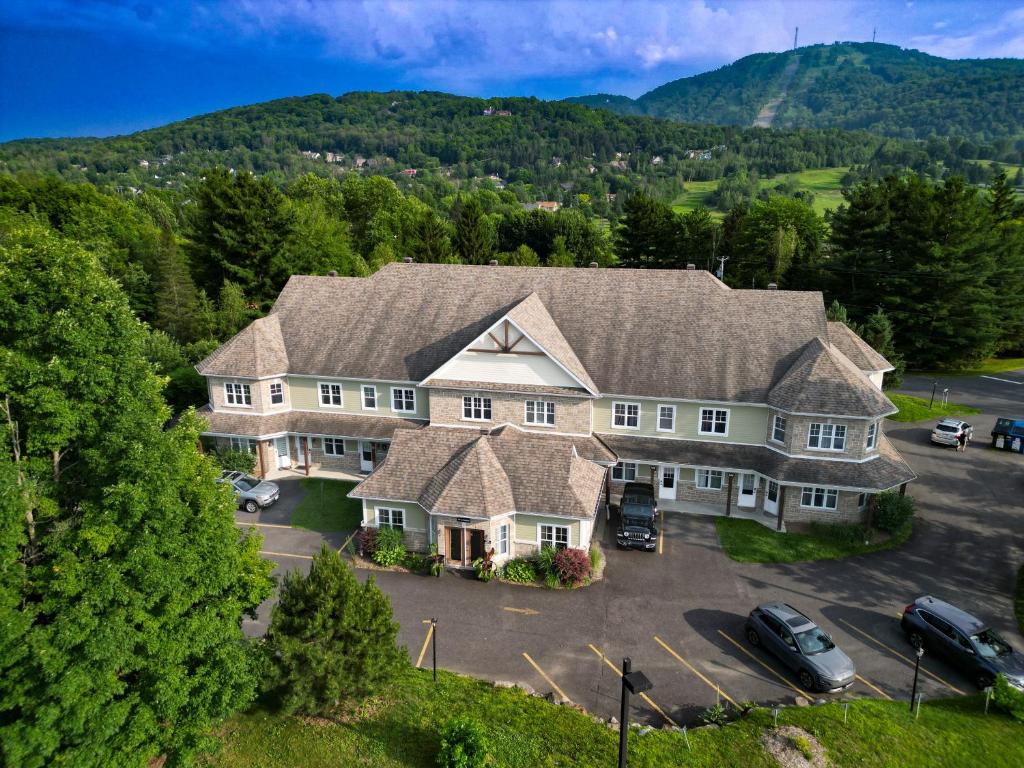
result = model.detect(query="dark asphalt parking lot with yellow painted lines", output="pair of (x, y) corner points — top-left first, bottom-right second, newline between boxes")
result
(244, 374), (1024, 725)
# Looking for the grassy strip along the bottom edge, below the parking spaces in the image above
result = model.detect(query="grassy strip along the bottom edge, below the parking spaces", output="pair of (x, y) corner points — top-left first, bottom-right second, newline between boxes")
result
(205, 670), (1024, 768)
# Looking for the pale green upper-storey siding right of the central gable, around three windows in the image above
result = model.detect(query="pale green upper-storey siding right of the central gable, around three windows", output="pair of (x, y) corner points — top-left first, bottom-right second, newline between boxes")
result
(594, 397), (769, 444)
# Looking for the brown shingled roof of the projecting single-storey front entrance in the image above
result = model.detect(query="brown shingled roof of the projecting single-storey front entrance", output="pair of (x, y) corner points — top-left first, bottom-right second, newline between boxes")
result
(349, 425), (614, 517)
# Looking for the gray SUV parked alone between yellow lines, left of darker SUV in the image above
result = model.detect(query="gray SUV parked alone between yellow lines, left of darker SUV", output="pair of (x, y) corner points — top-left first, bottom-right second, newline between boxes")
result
(746, 603), (857, 693)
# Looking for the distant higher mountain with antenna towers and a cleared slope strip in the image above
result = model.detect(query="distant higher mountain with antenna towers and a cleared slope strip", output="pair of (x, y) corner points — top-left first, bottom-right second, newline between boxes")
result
(567, 43), (1024, 144)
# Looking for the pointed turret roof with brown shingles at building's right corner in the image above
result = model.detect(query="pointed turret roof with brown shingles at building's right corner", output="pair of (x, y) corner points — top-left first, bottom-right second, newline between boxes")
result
(768, 337), (897, 417)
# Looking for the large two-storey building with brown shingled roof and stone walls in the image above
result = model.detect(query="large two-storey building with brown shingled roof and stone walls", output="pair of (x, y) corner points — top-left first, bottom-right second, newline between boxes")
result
(198, 262), (914, 565)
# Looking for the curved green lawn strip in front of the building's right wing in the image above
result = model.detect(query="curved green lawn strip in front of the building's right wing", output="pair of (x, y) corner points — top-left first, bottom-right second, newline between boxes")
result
(715, 517), (910, 562)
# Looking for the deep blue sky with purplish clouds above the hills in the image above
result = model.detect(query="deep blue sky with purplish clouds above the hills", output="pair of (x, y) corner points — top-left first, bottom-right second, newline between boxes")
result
(0, 0), (1024, 140)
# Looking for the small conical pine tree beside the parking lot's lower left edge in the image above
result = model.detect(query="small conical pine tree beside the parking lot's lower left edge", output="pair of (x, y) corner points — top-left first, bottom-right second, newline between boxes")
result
(266, 544), (409, 715)
